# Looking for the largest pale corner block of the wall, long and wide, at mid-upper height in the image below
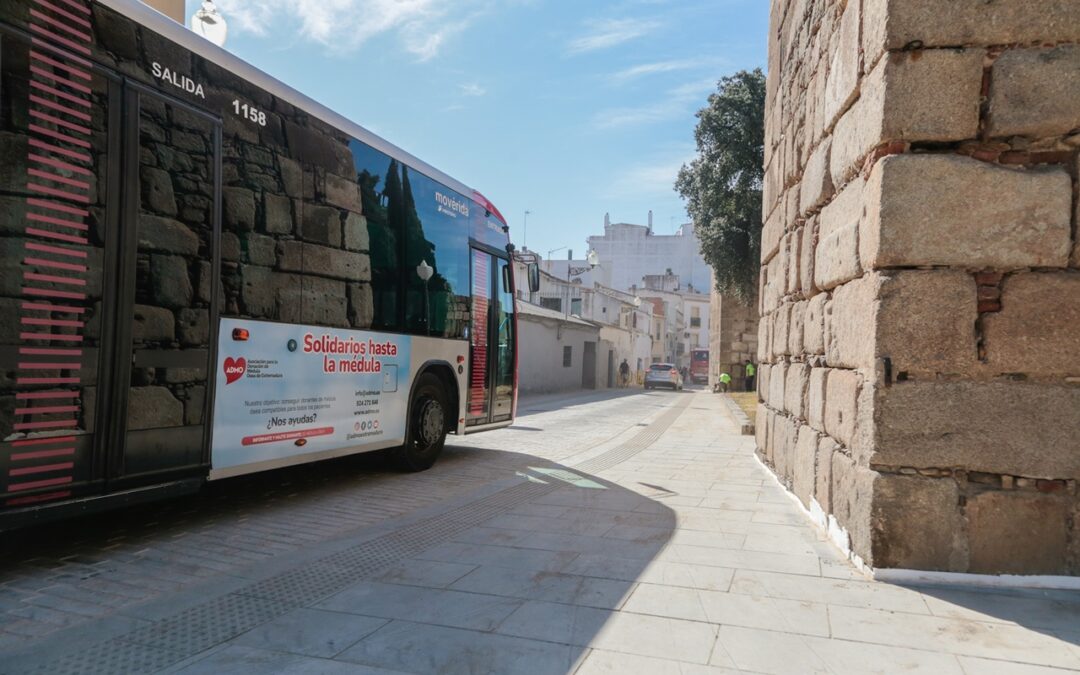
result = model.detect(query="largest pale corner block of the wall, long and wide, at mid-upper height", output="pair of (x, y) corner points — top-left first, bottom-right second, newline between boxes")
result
(859, 154), (1072, 269)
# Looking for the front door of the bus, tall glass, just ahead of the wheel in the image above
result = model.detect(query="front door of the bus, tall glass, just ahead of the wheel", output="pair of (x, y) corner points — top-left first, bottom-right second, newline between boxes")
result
(465, 248), (517, 426)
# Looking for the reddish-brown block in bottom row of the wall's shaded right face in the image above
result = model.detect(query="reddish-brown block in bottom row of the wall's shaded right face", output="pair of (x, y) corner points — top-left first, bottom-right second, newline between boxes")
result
(966, 490), (1070, 575)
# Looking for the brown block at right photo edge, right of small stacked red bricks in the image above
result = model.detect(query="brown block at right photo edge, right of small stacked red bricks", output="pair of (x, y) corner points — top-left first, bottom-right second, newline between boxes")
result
(983, 272), (1080, 377)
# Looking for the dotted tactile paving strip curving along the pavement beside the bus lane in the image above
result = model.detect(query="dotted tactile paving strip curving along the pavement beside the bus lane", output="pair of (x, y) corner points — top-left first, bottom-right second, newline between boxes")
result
(35, 396), (690, 675)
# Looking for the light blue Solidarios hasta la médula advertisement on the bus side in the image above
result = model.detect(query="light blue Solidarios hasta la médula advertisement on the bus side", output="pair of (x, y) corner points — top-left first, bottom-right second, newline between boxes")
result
(211, 319), (411, 476)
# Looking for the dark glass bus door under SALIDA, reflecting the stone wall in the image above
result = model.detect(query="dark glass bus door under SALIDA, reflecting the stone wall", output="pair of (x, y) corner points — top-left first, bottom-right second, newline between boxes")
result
(108, 82), (220, 480)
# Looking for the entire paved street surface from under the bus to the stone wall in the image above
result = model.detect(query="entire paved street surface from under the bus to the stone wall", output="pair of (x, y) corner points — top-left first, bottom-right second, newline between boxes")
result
(0, 391), (1080, 675)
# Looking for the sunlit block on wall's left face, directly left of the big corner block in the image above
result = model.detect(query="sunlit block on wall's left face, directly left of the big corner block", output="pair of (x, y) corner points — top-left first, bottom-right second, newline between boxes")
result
(814, 178), (863, 291)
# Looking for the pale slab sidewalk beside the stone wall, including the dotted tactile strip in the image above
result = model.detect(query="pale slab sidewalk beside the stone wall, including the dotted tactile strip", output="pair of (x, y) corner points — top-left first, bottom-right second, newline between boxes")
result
(8, 392), (1080, 675)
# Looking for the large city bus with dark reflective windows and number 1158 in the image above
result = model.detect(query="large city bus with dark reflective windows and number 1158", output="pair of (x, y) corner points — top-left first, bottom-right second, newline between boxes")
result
(0, 0), (538, 529)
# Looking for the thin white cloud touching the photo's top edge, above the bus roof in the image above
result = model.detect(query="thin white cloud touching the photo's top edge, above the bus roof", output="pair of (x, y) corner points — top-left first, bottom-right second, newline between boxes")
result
(217, 0), (477, 60)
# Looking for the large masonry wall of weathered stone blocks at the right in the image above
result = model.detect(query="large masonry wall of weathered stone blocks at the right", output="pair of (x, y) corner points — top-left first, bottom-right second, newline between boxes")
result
(757, 0), (1080, 575)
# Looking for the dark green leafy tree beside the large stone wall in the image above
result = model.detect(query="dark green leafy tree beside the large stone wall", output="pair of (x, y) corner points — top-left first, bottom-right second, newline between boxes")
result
(675, 68), (765, 301)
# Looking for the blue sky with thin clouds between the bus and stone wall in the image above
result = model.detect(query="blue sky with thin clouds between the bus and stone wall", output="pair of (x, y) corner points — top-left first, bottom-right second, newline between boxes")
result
(187, 0), (769, 258)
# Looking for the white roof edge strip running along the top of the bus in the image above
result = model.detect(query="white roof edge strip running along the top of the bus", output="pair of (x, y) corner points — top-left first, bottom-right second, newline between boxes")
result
(97, 0), (488, 216)
